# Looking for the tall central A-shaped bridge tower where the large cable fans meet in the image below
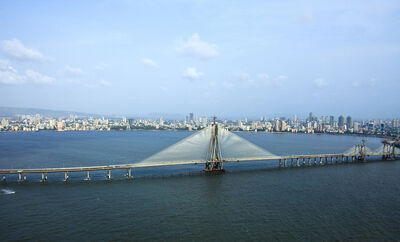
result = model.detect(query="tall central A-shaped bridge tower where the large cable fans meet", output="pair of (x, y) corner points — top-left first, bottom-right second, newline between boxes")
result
(204, 117), (225, 172)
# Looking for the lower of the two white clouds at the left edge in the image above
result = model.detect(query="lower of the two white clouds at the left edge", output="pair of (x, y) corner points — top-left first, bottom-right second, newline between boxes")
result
(0, 61), (54, 84)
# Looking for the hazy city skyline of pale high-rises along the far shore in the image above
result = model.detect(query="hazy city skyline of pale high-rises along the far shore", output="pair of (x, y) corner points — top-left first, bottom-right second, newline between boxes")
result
(0, 110), (400, 137)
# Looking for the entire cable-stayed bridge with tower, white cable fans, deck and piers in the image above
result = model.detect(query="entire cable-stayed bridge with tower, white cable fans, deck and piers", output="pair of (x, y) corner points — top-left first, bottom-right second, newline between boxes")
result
(0, 120), (400, 182)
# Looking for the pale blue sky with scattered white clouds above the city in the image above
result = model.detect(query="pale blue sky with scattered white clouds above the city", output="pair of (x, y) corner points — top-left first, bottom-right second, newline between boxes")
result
(0, 0), (400, 118)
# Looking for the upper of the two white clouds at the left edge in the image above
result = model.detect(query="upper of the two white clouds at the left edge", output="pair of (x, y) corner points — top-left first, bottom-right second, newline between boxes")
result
(0, 39), (49, 61)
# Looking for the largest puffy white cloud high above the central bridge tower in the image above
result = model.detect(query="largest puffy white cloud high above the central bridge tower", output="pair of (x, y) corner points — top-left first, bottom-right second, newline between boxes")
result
(177, 33), (218, 59)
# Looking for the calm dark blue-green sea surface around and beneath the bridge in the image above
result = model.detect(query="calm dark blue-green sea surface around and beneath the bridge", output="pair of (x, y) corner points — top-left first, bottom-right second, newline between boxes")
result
(0, 131), (400, 241)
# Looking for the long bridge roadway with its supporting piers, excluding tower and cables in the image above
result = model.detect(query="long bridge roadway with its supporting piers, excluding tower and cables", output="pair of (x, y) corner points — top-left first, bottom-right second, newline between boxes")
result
(0, 152), (400, 182)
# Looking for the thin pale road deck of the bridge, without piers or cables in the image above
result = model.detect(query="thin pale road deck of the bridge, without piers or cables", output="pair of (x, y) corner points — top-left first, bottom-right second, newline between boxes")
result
(0, 153), (400, 175)
